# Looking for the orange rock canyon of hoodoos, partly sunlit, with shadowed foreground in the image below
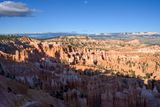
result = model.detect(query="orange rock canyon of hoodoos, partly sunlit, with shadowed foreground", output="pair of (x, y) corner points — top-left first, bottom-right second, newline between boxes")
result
(0, 37), (160, 107)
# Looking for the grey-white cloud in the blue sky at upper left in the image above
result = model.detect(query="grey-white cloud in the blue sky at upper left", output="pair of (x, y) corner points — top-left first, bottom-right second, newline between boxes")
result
(0, 1), (36, 17)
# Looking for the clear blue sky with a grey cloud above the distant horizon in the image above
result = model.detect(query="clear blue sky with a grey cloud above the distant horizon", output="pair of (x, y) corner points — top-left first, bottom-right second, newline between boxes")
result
(0, 0), (160, 34)
